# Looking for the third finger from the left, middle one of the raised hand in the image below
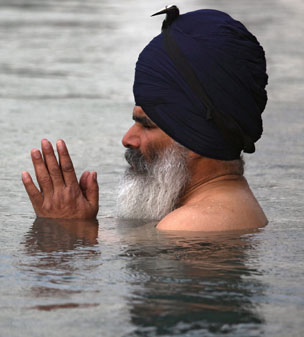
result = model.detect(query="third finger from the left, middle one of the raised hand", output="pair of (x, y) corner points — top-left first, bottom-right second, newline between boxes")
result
(41, 139), (64, 188)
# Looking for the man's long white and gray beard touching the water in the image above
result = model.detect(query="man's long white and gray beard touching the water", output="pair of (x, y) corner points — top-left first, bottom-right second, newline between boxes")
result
(117, 143), (190, 220)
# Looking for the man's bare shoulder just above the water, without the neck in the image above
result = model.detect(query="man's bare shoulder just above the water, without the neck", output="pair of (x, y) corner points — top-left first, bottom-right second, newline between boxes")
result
(157, 186), (267, 231)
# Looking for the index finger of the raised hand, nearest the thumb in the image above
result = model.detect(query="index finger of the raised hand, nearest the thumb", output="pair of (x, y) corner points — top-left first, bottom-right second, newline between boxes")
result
(57, 139), (78, 186)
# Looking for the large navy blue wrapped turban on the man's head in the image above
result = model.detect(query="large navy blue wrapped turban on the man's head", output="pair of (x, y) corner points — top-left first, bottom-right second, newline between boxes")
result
(133, 10), (268, 160)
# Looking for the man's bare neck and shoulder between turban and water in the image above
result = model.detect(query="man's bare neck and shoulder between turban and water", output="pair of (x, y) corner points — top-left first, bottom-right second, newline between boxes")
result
(157, 154), (267, 232)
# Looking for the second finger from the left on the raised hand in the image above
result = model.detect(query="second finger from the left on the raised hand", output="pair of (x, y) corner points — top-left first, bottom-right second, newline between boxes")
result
(31, 149), (53, 195)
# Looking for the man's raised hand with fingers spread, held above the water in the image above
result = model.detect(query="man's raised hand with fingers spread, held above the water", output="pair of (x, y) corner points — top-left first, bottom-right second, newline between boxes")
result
(22, 139), (98, 219)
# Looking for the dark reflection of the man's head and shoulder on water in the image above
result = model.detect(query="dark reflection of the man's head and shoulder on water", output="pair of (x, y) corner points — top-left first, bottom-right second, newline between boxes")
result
(120, 227), (264, 336)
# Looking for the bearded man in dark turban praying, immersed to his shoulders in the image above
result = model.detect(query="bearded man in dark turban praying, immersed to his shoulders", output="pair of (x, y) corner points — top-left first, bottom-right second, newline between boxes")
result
(22, 6), (267, 231)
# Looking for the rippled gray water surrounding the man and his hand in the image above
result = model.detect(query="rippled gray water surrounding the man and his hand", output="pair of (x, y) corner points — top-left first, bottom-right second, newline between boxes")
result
(0, 0), (304, 337)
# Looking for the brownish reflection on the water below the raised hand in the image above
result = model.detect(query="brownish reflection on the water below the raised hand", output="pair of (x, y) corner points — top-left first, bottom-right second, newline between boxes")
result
(20, 218), (100, 310)
